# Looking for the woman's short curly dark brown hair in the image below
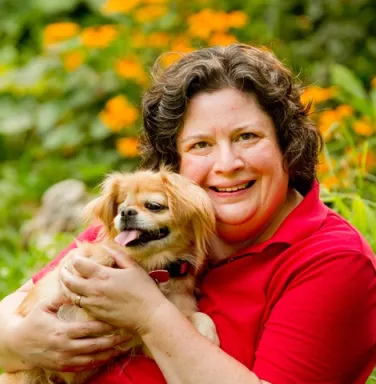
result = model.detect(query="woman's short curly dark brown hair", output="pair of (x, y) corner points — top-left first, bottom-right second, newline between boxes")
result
(141, 44), (322, 194)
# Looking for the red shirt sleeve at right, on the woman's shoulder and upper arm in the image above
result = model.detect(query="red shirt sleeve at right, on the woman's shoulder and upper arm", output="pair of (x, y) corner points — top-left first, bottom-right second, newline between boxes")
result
(253, 253), (376, 384)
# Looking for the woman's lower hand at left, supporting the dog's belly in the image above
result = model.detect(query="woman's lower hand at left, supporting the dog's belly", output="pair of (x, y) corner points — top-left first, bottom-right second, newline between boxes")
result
(5, 294), (129, 371)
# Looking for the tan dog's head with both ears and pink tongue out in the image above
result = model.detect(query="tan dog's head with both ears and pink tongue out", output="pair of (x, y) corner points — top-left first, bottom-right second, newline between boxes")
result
(85, 169), (215, 262)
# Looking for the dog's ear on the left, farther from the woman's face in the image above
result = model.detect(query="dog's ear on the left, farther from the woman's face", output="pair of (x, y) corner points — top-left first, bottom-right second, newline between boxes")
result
(83, 172), (124, 233)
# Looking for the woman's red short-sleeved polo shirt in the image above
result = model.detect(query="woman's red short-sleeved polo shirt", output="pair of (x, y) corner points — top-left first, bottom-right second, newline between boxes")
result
(34, 184), (376, 384)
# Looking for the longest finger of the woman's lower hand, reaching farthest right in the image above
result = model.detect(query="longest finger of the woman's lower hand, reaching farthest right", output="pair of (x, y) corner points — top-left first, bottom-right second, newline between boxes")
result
(71, 334), (133, 355)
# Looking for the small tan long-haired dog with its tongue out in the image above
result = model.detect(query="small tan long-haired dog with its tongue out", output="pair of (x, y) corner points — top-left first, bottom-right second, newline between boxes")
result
(0, 170), (219, 384)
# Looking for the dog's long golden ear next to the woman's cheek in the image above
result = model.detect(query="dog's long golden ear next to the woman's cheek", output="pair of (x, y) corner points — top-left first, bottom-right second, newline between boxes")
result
(161, 169), (215, 255)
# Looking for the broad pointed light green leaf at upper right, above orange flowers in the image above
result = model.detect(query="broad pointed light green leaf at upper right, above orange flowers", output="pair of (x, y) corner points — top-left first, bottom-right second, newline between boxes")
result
(331, 64), (367, 99)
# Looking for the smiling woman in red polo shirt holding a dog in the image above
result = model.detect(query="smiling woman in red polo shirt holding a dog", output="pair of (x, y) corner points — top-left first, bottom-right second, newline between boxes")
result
(0, 45), (376, 384)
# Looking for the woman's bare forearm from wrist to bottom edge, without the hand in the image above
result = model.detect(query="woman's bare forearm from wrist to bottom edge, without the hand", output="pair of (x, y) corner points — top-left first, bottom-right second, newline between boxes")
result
(142, 300), (267, 384)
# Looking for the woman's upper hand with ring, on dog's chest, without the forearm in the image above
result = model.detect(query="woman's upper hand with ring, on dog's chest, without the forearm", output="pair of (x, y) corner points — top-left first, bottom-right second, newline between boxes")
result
(60, 248), (167, 334)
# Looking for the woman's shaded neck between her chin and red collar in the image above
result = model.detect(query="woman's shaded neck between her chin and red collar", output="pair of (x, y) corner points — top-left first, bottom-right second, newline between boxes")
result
(210, 189), (303, 261)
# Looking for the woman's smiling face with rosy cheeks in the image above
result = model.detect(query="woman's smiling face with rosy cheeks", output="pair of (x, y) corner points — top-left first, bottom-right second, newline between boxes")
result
(178, 88), (288, 243)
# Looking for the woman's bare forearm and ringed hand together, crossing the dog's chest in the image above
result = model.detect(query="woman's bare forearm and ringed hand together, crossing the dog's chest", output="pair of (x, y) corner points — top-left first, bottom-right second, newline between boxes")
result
(61, 251), (266, 384)
